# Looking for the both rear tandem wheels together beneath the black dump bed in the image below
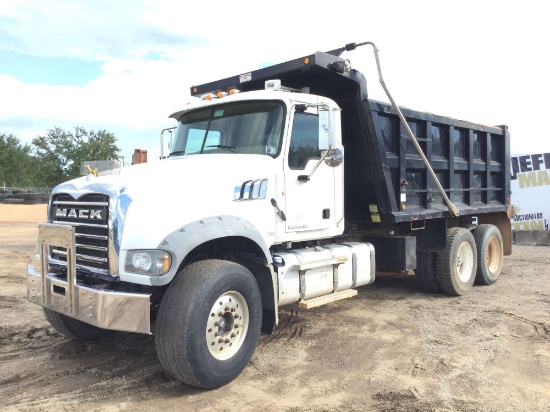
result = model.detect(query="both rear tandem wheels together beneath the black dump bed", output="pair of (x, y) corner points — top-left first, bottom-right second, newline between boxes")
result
(416, 224), (503, 296)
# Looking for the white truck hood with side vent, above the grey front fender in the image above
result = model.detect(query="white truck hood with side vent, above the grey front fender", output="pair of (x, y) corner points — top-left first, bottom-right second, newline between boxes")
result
(54, 154), (276, 249)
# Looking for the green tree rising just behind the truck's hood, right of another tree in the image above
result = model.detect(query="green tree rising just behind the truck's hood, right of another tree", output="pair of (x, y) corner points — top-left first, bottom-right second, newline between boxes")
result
(32, 127), (120, 186)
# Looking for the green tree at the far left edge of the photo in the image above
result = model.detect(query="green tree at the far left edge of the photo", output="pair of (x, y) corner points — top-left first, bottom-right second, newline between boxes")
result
(0, 133), (41, 187)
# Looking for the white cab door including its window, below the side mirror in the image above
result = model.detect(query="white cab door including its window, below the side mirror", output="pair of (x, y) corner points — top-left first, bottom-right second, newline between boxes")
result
(285, 108), (336, 233)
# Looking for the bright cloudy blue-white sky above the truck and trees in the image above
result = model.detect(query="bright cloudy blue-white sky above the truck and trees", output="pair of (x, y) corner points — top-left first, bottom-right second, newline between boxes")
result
(0, 0), (550, 163)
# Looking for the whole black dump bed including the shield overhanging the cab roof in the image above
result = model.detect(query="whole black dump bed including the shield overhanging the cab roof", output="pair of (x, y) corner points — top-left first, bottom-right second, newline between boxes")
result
(191, 52), (510, 223)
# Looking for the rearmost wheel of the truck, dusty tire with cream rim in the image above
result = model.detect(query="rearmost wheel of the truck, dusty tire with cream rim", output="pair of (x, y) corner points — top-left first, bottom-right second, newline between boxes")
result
(473, 225), (504, 285)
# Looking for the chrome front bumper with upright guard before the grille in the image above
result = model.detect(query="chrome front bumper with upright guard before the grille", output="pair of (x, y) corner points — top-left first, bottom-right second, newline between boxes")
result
(27, 223), (151, 334)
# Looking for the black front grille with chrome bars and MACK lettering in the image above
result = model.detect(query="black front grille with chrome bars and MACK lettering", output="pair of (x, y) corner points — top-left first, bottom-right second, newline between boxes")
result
(50, 194), (109, 274)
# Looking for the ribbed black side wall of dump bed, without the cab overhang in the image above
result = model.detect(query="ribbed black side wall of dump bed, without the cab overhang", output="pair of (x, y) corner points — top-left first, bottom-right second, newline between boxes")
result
(338, 99), (510, 223)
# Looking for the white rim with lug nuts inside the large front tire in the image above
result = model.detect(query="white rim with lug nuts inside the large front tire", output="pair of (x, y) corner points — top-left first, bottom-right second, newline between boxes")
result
(206, 291), (249, 360)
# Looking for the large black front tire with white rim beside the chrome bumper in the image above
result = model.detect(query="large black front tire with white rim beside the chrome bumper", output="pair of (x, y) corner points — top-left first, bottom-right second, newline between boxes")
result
(155, 260), (262, 388)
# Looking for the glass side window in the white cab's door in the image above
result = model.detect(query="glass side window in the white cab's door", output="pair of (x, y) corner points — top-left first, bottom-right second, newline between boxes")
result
(288, 112), (321, 170)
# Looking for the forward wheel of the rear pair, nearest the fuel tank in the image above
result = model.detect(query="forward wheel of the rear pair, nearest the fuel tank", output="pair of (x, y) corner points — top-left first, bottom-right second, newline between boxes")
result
(436, 227), (477, 296)
